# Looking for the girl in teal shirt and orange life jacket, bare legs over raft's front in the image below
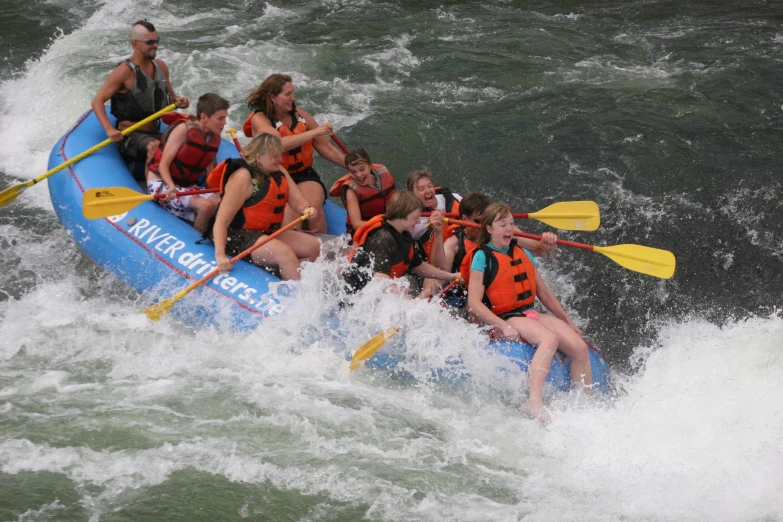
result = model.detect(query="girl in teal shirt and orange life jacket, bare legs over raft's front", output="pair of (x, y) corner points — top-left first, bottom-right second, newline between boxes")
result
(460, 203), (592, 422)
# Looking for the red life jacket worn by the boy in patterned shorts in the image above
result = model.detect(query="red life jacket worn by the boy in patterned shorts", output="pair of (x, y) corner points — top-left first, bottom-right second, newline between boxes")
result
(149, 119), (220, 187)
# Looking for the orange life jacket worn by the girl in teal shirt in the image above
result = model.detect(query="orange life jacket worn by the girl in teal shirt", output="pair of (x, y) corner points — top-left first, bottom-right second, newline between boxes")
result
(460, 240), (536, 315)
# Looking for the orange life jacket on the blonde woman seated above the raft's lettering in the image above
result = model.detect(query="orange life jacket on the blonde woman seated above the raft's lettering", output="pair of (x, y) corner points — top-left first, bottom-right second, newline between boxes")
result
(210, 158), (288, 232)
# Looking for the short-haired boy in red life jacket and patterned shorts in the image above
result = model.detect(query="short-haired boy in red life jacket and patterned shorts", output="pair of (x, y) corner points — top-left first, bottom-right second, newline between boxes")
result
(147, 93), (229, 233)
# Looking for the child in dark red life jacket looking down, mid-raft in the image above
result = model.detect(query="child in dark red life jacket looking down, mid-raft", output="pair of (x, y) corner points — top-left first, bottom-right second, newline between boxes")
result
(329, 148), (395, 237)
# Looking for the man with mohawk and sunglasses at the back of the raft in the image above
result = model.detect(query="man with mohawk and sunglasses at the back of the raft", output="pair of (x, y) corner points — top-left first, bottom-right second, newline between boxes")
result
(92, 20), (190, 179)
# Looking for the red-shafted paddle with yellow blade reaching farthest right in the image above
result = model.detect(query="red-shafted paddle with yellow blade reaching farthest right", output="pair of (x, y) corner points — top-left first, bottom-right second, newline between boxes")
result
(445, 218), (677, 279)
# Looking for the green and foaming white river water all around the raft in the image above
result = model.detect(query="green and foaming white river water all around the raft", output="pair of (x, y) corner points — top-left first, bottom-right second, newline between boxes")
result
(0, 0), (783, 521)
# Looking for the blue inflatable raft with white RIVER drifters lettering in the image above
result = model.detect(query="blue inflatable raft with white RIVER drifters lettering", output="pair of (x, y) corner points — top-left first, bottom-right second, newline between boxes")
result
(49, 111), (609, 390)
